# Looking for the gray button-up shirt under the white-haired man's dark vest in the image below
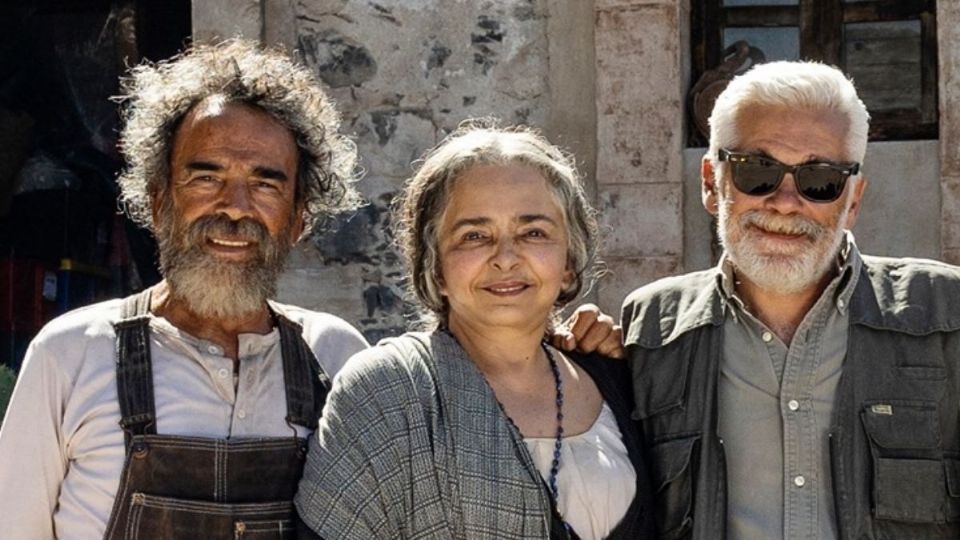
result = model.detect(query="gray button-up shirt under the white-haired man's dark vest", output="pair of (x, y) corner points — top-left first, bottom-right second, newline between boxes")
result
(718, 238), (862, 540)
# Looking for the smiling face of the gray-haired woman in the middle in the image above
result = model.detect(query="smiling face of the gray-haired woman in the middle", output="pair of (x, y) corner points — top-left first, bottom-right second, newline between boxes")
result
(438, 164), (572, 334)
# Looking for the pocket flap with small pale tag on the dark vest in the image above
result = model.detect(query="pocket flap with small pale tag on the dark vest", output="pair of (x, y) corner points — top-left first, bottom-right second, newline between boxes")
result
(861, 400), (940, 449)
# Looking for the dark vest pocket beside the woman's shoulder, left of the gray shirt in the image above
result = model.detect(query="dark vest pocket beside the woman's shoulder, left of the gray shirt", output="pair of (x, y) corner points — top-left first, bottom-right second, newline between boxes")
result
(650, 434), (700, 540)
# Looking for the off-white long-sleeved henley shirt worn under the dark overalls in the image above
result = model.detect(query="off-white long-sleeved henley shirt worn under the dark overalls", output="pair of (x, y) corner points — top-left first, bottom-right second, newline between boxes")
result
(0, 300), (367, 540)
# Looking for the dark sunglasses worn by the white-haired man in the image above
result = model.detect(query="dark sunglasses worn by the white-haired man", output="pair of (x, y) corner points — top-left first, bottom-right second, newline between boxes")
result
(718, 148), (860, 203)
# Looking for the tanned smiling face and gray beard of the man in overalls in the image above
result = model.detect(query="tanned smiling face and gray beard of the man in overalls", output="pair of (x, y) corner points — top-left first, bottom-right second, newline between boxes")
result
(154, 98), (302, 317)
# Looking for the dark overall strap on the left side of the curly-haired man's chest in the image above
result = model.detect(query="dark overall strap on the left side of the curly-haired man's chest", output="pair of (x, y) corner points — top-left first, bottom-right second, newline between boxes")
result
(113, 289), (157, 447)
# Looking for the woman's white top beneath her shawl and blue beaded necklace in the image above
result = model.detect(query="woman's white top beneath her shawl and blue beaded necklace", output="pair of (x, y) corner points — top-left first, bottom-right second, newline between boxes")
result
(524, 402), (637, 540)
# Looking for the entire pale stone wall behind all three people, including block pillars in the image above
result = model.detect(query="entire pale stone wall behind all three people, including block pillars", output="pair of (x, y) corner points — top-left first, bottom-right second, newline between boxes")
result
(194, 0), (960, 332)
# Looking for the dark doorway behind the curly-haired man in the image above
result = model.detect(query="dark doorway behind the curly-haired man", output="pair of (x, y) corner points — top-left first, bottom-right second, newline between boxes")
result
(0, 0), (190, 369)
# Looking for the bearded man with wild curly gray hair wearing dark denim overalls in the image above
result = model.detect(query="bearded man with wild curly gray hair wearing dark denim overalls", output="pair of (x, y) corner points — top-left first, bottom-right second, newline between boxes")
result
(0, 40), (366, 538)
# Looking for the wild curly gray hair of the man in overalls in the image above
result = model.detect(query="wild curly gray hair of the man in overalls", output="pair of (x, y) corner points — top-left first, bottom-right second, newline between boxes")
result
(116, 39), (361, 235)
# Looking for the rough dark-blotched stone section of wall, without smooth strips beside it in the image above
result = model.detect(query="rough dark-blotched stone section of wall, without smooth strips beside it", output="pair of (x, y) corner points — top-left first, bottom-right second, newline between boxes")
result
(282, 0), (548, 340)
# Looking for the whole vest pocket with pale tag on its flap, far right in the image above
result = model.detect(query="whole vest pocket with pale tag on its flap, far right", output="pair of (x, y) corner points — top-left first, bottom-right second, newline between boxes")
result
(860, 400), (960, 524)
